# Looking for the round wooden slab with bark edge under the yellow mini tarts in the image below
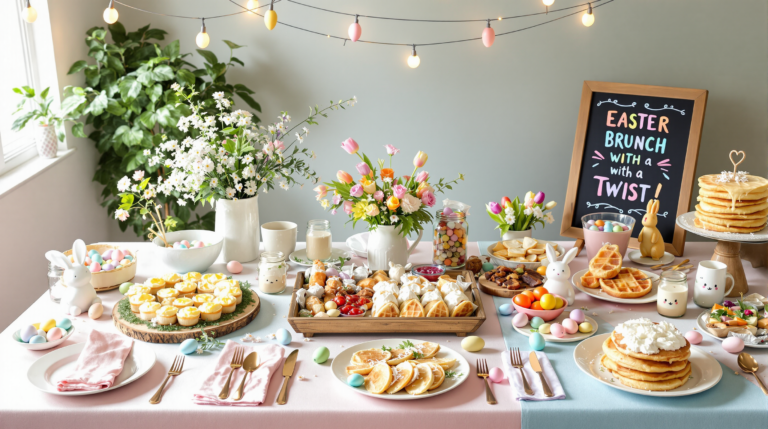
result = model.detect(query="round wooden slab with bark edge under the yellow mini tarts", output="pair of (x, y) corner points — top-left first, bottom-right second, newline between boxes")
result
(112, 290), (261, 344)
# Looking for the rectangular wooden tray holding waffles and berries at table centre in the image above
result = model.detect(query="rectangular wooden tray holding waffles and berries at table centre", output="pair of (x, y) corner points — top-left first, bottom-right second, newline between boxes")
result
(288, 270), (485, 337)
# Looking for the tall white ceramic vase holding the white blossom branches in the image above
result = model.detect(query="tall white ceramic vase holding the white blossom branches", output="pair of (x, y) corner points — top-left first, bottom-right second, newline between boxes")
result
(215, 195), (260, 262)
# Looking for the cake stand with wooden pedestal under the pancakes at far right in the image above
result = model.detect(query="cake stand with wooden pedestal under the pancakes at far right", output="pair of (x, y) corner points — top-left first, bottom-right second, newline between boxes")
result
(675, 212), (768, 297)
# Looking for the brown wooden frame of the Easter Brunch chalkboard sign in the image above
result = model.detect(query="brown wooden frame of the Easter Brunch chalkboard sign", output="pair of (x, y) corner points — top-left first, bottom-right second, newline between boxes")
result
(560, 81), (709, 256)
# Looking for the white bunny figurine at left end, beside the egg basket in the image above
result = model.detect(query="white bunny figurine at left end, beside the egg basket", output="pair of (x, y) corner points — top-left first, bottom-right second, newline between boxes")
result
(45, 239), (101, 316)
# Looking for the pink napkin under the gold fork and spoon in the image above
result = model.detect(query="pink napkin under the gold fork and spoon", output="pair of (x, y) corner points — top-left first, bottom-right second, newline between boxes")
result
(192, 340), (285, 407)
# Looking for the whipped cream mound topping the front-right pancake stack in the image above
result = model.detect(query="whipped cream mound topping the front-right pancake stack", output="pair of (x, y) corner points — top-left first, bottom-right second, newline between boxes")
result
(616, 317), (686, 355)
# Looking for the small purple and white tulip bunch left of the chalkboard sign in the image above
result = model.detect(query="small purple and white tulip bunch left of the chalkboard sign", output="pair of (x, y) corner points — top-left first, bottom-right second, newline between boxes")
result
(485, 191), (557, 237)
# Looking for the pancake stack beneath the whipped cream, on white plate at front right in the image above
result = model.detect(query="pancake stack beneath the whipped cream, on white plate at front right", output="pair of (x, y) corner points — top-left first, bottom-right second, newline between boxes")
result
(600, 331), (691, 392)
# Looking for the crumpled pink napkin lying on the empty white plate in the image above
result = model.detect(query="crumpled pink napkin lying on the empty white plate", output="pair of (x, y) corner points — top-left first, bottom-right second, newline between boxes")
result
(56, 329), (133, 392)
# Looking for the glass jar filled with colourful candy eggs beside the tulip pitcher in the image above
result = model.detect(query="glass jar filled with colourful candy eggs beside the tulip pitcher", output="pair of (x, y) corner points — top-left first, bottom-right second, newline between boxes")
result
(432, 210), (469, 268)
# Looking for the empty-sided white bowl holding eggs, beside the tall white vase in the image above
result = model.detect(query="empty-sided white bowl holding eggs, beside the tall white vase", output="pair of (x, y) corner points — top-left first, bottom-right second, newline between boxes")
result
(153, 229), (224, 274)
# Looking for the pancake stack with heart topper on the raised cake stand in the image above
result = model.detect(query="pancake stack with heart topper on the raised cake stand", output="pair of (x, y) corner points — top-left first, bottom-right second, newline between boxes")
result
(694, 172), (768, 234)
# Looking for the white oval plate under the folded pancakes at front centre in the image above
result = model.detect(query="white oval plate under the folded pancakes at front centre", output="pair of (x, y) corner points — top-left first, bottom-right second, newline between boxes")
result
(331, 338), (471, 401)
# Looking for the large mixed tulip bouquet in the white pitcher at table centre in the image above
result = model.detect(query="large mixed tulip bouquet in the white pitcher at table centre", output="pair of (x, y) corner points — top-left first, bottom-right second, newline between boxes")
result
(314, 138), (464, 236)
